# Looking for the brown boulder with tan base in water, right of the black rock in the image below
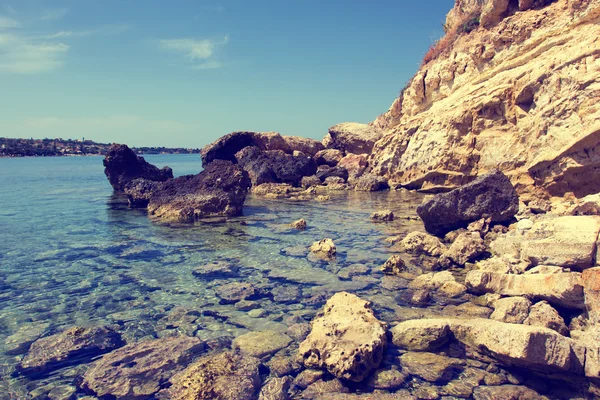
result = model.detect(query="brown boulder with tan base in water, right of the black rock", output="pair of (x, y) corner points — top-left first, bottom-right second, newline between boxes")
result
(148, 160), (250, 222)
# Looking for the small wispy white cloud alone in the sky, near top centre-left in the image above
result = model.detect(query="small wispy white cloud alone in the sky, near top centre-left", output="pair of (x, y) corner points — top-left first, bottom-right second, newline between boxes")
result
(159, 36), (229, 69)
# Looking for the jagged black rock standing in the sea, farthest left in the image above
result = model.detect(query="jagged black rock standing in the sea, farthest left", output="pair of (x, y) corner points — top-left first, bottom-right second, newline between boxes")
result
(103, 144), (173, 192)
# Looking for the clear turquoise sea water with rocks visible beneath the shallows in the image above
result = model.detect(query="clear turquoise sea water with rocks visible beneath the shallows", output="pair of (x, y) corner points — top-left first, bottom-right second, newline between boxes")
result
(0, 155), (422, 398)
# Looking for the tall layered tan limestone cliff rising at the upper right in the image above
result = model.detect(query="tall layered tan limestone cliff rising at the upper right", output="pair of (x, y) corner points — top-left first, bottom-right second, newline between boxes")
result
(370, 0), (600, 196)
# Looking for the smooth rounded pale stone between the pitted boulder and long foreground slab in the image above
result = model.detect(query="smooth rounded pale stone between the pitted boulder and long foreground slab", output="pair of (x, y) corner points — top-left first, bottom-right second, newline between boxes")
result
(391, 319), (450, 351)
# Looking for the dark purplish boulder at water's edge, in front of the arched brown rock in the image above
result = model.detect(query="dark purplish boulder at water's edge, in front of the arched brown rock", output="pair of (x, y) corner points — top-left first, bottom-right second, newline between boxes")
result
(235, 146), (317, 186)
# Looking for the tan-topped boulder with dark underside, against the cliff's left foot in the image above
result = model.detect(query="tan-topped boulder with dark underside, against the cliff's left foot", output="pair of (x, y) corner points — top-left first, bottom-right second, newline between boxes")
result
(323, 122), (381, 154)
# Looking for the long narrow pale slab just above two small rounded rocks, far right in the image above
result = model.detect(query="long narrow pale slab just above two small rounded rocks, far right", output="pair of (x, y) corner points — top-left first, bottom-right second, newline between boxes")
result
(465, 271), (584, 309)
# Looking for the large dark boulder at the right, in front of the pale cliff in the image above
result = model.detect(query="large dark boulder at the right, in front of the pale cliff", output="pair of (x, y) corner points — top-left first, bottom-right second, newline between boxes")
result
(417, 171), (519, 236)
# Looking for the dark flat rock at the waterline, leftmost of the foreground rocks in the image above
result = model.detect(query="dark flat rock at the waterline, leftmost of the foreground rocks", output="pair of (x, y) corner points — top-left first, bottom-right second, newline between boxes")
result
(17, 327), (124, 375)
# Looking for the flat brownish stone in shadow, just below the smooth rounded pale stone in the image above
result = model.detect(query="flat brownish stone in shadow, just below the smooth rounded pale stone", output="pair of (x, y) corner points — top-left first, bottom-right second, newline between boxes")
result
(400, 351), (464, 383)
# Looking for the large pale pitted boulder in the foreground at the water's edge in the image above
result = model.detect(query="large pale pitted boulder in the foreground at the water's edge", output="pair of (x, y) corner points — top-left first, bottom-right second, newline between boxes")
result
(298, 292), (387, 382)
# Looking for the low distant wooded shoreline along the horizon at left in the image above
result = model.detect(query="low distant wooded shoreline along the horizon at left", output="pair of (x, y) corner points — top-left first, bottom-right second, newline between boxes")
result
(0, 138), (200, 157)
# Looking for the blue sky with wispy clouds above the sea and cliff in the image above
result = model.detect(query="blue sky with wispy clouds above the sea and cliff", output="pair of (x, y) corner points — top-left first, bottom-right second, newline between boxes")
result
(0, 0), (454, 148)
